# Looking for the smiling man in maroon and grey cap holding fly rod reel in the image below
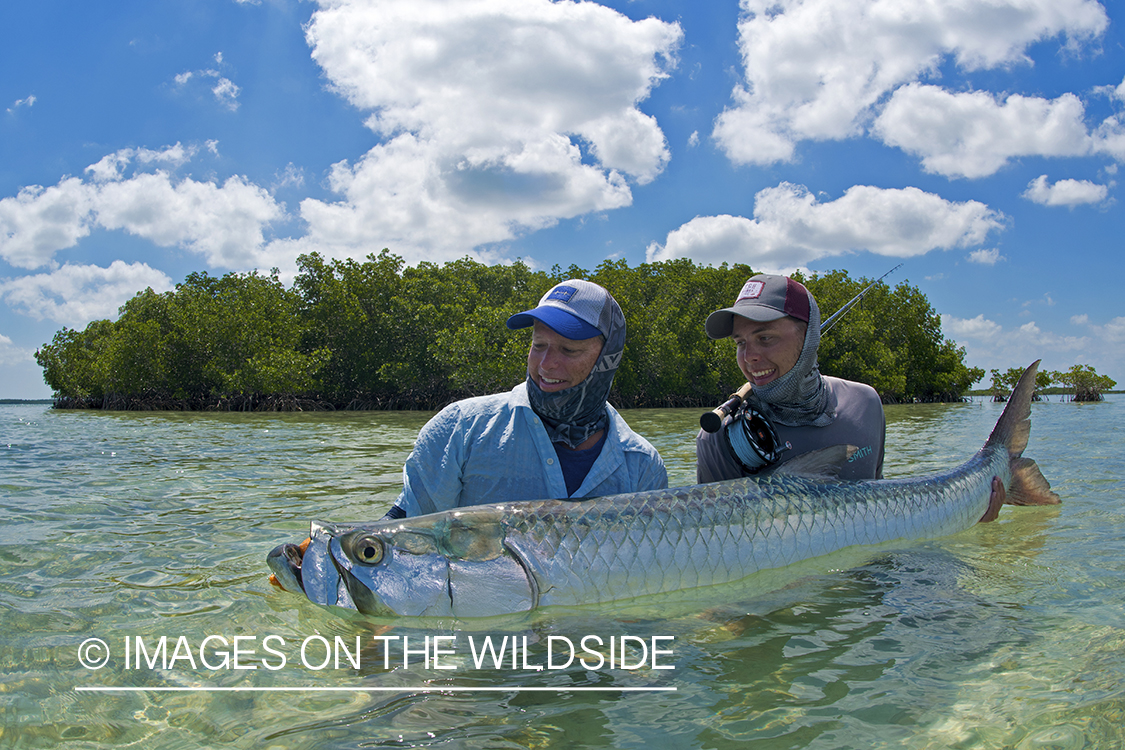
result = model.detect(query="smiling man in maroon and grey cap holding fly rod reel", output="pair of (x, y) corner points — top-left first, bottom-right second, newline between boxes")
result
(695, 274), (887, 482)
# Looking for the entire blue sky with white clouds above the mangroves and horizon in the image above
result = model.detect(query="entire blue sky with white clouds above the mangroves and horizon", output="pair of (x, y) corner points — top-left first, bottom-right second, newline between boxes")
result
(0, 0), (1125, 398)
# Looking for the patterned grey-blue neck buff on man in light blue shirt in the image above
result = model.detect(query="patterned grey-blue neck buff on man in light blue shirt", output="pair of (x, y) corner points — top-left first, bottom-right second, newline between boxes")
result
(528, 295), (626, 448)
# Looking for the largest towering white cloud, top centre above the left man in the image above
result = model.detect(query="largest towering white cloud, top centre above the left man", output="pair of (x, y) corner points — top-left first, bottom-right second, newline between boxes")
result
(279, 0), (682, 260)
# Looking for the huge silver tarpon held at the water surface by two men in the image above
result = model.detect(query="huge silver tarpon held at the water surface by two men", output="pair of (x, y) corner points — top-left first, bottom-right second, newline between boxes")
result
(268, 362), (1059, 617)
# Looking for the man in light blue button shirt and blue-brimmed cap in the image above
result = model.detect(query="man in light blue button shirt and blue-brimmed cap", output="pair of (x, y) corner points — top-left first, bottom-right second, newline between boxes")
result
(387, 279), (668, 518)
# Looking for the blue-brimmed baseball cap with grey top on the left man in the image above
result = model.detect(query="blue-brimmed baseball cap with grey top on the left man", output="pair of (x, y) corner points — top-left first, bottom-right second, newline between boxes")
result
(507, 279), (624, 341)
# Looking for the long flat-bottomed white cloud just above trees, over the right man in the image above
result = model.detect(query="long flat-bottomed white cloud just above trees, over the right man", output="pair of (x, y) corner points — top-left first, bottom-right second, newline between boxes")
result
(647, 182), (1004, 271)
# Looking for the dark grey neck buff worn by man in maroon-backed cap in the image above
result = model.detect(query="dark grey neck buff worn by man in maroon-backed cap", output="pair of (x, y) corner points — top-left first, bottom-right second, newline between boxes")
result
(747, 295), (836, 427)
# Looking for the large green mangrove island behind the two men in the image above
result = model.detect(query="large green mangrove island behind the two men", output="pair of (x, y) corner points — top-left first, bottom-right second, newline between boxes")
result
(36, 256), (999, 408)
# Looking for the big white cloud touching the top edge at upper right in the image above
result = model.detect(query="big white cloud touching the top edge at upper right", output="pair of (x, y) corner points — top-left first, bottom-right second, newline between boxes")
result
(713, 0), (1108, 164)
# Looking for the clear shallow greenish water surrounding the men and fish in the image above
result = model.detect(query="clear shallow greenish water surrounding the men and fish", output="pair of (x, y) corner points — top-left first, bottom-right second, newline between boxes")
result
(0, 396), (1125, 750)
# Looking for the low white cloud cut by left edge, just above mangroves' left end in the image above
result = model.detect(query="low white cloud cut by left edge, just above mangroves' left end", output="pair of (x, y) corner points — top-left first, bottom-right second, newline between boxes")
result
(0, 261), (172, 328)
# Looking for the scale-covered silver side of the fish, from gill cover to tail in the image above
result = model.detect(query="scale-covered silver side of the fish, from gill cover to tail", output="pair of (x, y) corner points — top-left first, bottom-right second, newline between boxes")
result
(505, 457), (1000, 606)
